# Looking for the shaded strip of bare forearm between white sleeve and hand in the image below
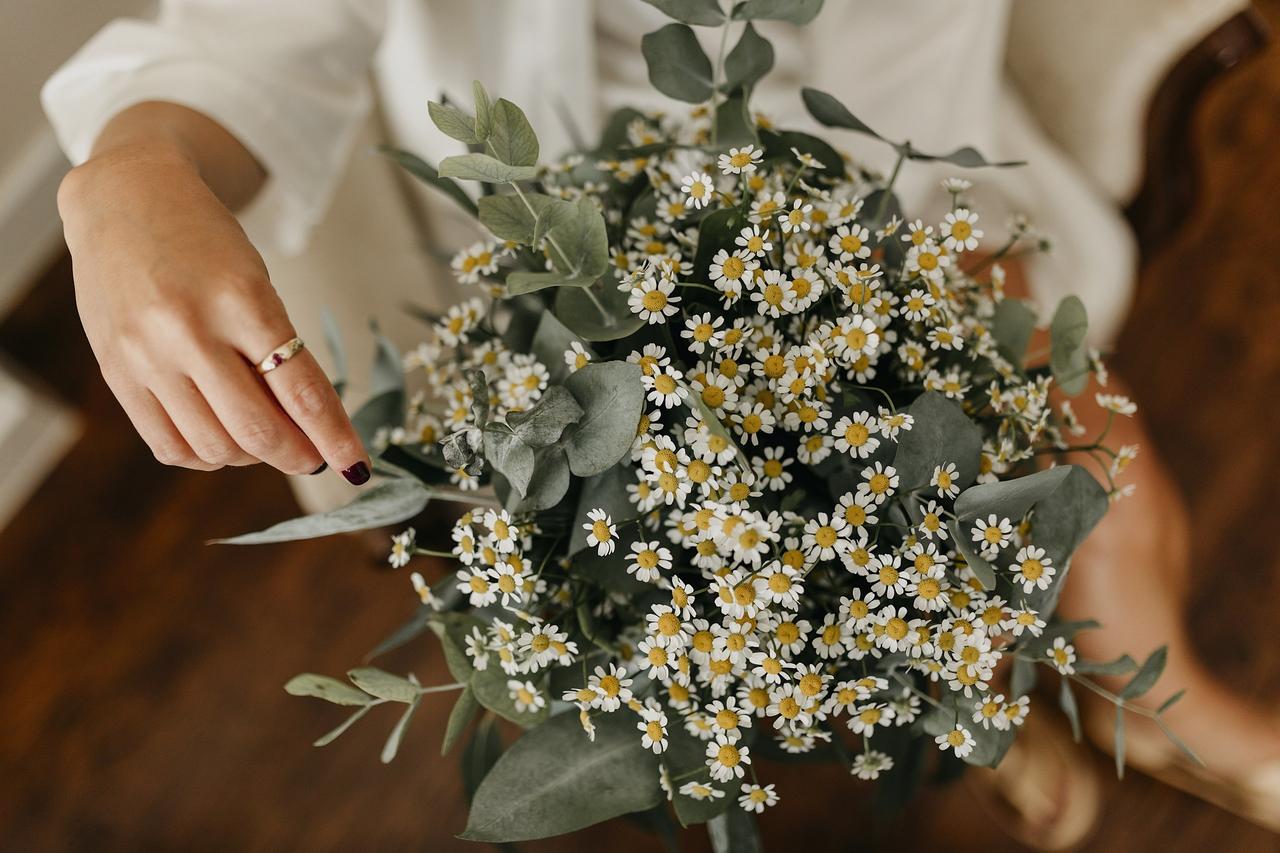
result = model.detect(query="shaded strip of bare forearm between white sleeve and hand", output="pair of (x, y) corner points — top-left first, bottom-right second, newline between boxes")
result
(91, 101), (266, 210)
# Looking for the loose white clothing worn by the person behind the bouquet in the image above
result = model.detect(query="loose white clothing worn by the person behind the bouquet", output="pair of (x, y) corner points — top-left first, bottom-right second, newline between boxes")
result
(44, 0), (1135, 342)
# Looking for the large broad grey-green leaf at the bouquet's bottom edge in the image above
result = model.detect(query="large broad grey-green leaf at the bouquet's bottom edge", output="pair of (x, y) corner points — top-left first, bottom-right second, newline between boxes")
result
(461, 712), (662, 843)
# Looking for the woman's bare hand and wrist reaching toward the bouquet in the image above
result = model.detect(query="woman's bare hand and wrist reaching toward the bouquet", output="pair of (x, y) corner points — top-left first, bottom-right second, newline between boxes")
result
(58, 102), (370, 484)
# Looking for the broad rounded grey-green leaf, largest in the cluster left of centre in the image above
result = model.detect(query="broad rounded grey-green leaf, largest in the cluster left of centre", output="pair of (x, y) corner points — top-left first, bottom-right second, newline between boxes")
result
(562, 361), (644, 476)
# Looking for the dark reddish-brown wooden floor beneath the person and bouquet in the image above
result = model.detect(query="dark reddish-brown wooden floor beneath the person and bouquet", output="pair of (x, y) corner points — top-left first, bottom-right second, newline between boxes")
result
(0, 0), (1280, 853)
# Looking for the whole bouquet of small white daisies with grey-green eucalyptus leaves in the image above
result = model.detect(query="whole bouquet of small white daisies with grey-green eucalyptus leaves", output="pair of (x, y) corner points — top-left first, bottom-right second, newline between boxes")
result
(222, 0), (1187, 835)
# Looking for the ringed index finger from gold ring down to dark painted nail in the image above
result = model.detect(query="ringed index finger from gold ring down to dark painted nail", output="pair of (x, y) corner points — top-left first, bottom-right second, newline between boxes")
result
(262, 350), (371, 485)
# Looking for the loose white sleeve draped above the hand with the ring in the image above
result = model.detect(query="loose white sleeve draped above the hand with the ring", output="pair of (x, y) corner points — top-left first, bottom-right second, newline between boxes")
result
(41, 0), (385, 254)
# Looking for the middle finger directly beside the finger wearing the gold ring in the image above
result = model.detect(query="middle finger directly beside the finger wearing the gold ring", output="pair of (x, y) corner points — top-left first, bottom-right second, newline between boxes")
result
(193, 347), (324, 474)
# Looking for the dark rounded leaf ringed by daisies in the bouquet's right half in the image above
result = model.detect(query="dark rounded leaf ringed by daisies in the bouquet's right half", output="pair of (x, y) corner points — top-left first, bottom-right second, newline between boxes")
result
(893, 391), (982, 492)
